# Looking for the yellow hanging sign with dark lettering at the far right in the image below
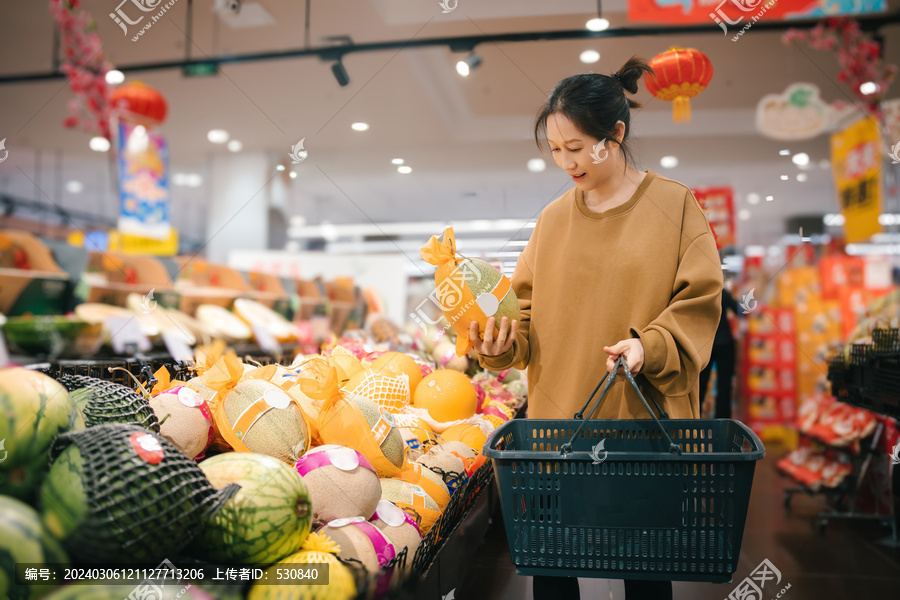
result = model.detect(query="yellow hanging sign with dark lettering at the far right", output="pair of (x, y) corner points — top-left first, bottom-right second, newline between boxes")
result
(831, 118), (883, 243)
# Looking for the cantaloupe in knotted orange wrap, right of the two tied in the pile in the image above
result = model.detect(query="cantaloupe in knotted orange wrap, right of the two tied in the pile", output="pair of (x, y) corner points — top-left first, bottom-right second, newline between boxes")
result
(299, 358), (406, 477)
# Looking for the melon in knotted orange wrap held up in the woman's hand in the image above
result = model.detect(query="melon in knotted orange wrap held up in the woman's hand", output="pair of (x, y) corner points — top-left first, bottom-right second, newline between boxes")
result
(420, 227), (521, 356)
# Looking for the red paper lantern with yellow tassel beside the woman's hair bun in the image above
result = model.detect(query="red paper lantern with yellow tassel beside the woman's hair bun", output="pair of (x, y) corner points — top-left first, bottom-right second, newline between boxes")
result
(644, 48), (712, 123)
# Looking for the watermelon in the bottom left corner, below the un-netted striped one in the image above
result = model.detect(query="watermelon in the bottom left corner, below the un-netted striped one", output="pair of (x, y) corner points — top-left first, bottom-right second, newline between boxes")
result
(0, 496), (69, 600)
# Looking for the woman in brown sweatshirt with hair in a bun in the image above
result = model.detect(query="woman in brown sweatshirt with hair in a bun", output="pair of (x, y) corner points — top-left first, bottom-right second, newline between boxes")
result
(469, 58), (722, 600)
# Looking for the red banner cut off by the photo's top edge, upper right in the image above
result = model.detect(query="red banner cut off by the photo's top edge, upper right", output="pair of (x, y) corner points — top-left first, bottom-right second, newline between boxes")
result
(628, 0), (887, 25)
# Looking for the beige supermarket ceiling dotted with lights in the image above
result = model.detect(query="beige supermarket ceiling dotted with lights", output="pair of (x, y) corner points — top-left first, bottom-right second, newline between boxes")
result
(0, 0), (900, 244)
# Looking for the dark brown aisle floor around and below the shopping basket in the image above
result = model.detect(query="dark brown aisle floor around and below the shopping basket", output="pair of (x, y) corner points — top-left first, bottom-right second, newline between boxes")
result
(453, 447), (900, 600)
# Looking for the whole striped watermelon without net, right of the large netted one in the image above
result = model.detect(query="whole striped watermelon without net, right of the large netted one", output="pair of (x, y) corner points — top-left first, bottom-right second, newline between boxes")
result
(194, 452), (312, 564)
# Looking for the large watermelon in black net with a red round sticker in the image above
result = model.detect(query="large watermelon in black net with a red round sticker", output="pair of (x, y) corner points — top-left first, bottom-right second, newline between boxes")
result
(41, 424), (238, 562)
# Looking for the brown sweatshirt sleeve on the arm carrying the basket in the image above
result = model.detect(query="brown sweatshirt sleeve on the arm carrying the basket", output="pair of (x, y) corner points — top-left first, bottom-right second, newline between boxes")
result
(631, 225), (722, 396)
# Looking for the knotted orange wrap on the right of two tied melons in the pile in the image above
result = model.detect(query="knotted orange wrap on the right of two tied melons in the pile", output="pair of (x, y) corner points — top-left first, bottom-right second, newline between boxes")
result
(299, 358), (400, 477)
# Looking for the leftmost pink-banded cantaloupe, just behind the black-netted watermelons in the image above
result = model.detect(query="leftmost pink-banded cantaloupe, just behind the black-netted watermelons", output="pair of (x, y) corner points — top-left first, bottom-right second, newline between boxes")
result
(150, 385), (214, 458)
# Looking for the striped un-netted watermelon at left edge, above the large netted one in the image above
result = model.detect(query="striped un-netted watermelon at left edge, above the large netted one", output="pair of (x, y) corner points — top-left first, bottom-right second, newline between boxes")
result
(0, 367), (78, 503)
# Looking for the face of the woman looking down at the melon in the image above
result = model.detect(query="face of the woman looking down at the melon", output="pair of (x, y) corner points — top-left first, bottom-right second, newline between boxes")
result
(547, 113), (624, 192)
